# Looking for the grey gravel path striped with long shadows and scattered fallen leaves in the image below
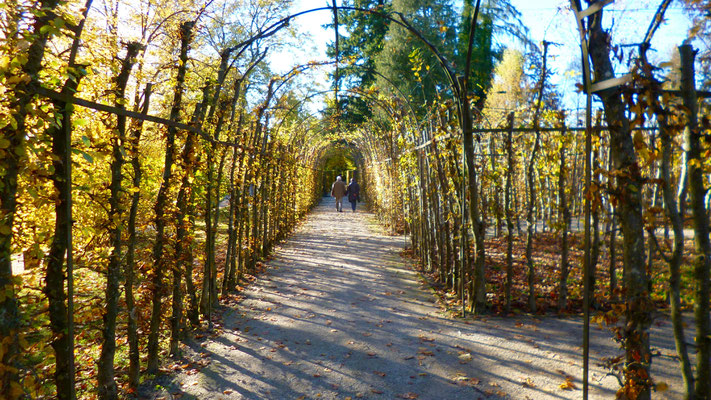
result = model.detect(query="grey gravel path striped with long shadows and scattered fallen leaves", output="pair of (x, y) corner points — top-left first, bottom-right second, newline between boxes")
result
(153, 198), (681, 399)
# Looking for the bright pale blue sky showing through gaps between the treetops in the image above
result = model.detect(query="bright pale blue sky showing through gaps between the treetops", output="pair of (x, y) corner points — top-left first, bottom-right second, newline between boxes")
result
(272, 0), (690, 115)
